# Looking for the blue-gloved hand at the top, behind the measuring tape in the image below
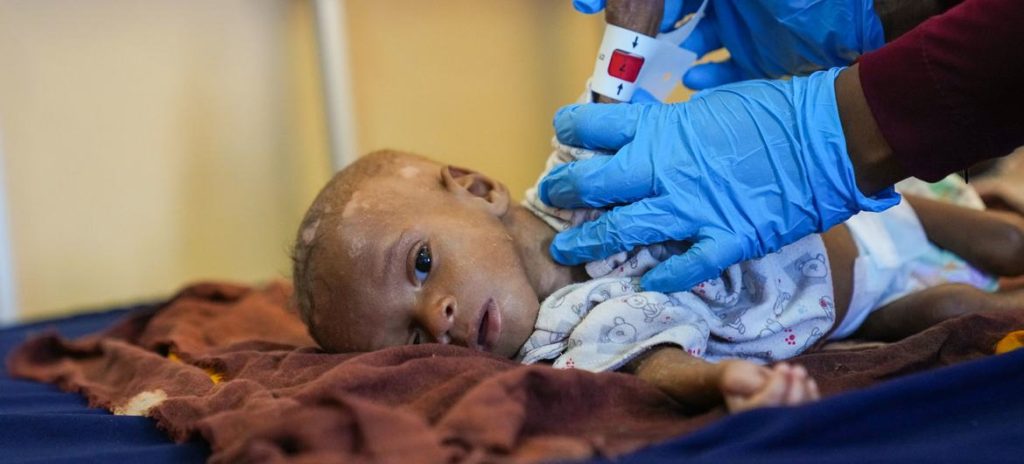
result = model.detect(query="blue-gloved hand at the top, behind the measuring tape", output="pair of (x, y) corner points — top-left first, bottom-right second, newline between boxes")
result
(572, 0), (885, 90)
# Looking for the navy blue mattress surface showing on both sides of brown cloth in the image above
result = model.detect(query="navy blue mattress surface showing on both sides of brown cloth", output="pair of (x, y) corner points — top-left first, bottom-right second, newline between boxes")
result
(0, 308), (1024, 464)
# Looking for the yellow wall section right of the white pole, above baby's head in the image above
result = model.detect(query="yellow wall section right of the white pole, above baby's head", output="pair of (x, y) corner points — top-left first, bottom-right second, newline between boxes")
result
(347, 0), (603, 196)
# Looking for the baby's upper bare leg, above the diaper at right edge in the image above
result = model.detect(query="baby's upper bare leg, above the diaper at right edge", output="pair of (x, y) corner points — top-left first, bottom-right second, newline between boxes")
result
(904, 195), (1024, 277)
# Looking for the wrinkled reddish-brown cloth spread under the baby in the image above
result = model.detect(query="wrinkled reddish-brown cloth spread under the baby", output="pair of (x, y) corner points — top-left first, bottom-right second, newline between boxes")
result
(8, 284), (1024, 463)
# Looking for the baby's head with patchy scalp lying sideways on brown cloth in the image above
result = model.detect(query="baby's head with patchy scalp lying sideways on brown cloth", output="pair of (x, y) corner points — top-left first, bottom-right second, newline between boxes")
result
(294, 151), (539, 357)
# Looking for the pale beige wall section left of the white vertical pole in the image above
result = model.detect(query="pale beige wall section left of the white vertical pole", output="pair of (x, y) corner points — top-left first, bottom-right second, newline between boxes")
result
(0, 0), (329, 319)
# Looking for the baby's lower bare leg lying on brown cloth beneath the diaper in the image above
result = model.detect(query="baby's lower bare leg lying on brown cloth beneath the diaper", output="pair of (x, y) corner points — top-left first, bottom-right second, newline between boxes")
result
(853, 284), (1024, 341)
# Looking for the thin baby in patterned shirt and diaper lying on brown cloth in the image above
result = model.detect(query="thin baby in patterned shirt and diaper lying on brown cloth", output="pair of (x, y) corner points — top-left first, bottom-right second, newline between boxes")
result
(294, 147), (1024, 411)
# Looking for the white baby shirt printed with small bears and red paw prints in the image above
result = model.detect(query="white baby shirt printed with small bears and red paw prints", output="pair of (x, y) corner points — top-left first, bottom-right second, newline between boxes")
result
(517, 236), (836, 372)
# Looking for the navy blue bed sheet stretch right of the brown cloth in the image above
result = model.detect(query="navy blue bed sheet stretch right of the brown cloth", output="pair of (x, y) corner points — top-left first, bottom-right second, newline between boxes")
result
(593, 349), (1024, 464)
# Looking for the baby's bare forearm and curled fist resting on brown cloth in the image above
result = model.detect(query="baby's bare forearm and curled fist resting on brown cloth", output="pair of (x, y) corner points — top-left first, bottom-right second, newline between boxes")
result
(626, 346), (819, 412)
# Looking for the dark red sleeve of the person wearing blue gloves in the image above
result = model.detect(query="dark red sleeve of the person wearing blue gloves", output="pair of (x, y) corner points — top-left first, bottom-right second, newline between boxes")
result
(860, 0), (1024, 180)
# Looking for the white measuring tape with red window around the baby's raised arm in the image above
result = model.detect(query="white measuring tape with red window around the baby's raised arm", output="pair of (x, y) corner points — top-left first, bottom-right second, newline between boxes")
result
(590, 0), (708, 101)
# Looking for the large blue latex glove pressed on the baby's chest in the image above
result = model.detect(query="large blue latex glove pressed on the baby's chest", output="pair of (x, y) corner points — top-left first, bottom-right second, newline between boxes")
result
(539, 69), (899, 292)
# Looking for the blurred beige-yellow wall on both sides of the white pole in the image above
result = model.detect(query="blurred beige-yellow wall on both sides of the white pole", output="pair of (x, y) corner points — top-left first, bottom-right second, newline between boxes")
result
(0, 0), (622, 319)
